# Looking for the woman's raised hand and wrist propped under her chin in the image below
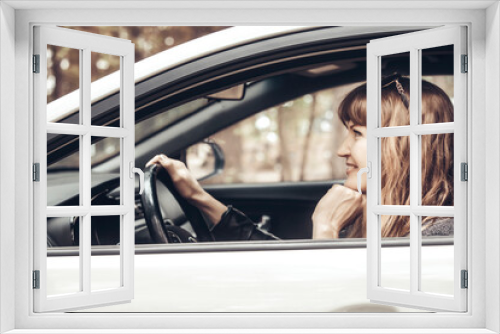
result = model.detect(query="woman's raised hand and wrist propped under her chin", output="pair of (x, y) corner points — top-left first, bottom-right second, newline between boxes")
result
(312, 184), (365, 239)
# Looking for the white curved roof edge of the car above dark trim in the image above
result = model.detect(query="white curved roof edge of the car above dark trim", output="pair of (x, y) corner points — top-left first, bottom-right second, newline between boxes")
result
(47, 26), (317, 122)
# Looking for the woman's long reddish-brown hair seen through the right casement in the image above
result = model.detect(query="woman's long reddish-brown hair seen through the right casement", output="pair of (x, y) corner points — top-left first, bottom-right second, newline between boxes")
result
(338, 76), (453, 238)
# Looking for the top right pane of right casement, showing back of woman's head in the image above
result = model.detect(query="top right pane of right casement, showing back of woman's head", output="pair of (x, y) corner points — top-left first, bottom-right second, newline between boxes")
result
(421, 45), (454, 124)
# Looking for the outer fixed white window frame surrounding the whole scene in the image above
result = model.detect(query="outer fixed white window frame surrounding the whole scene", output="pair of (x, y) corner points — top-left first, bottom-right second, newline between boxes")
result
(0, 1), (500, 333)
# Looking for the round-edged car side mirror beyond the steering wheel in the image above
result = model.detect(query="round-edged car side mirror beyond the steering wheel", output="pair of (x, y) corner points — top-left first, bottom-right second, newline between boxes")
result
(186, 139), (226, 181)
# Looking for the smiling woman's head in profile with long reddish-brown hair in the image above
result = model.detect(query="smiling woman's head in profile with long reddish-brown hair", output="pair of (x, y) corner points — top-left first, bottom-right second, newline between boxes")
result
(326, 75), (453, 237)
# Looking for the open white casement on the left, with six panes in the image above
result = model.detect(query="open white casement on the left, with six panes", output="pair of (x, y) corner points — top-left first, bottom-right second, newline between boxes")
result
(33, 26), (135, 312)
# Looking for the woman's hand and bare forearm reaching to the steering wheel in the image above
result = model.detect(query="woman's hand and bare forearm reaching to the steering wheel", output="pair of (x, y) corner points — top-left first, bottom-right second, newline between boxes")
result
(146, 154), (227, 225)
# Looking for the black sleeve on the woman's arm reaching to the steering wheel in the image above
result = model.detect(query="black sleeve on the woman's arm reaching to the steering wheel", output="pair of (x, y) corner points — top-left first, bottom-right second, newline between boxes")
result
(211, 205), (279, 241)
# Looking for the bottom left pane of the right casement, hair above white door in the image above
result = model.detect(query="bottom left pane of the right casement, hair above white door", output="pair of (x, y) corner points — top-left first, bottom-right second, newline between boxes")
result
(380, 216), (410, 291)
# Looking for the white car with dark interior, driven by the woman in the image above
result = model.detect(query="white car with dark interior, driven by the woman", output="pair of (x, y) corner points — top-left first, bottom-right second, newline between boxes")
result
(47, 27), (454, 312)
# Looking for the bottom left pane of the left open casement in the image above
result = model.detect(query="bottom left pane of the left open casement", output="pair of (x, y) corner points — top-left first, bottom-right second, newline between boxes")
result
(47, 217), (81, 296)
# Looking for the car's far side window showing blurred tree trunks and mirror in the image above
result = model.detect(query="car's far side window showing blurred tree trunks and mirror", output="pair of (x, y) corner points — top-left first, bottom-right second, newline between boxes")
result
(186, 83), (360, 184)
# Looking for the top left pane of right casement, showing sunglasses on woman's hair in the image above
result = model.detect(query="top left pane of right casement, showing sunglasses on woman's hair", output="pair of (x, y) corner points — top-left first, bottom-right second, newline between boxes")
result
(379, 52), (410, 127)
